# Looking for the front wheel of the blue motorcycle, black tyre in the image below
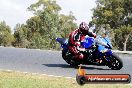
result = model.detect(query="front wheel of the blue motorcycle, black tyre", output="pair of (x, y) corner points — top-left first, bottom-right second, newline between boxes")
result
(108, 54), (123, 70)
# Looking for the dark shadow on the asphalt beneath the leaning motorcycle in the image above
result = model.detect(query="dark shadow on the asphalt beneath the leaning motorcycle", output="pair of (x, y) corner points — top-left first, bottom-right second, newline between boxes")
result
(42, 64), (111, 70)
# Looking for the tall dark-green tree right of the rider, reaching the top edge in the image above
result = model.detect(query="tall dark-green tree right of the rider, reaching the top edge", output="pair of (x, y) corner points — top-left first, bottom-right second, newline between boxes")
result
(92, 0), (132, 50)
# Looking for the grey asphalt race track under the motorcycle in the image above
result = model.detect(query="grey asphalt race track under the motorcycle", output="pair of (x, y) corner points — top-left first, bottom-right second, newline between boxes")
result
(0, 47), (132, 81)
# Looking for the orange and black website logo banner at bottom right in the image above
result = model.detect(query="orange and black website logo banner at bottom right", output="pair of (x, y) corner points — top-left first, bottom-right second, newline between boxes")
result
(76, 66), (131, 85)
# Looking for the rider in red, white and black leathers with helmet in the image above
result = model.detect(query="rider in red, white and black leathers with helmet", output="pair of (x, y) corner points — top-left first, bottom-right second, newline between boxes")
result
(69, 22), (96, 60)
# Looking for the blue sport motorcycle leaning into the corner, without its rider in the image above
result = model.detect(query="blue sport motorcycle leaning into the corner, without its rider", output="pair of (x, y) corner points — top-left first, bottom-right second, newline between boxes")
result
(56, 36), (123, 70)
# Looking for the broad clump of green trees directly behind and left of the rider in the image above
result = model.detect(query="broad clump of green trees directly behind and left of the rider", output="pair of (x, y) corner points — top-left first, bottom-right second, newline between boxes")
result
(14, 0), (77, 49)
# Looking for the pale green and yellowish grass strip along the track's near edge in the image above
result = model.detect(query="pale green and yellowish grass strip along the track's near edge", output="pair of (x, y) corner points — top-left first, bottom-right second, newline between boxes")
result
(0, 71), (132, 88)
